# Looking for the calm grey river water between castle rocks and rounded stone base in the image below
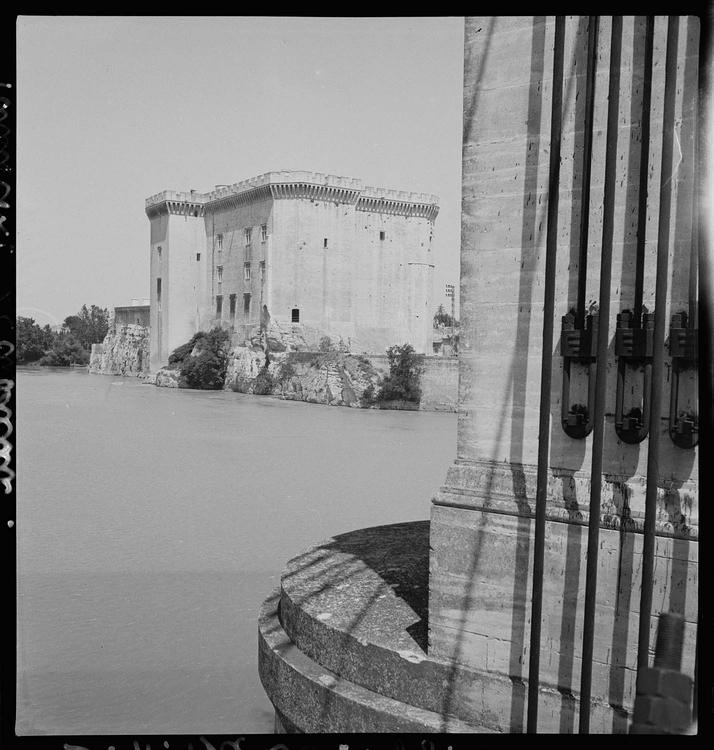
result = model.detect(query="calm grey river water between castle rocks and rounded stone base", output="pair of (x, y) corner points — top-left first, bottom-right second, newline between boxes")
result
(16, 370), (456, 734)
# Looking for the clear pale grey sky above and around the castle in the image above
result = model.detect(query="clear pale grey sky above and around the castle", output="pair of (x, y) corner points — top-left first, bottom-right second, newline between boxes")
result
(17, 16), (463, 323)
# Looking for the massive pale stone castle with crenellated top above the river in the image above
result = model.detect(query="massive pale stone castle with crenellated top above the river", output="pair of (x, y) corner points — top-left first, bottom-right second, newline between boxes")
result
(146, 172), (439, 368)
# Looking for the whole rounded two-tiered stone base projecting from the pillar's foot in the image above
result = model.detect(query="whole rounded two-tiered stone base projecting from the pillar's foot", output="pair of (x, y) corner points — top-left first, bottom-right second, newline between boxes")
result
(259, 521), (627, 733)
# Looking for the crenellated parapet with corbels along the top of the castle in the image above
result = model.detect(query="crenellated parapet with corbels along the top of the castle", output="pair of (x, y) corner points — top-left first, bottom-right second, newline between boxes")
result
(146, 170), (439, 220)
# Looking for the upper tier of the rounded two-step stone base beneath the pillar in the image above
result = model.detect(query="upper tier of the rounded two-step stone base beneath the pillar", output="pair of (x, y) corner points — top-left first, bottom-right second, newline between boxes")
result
(272, 521), (513, 731)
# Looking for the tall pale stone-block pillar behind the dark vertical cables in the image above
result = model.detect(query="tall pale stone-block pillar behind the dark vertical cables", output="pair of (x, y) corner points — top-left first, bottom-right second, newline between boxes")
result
(429, 16), (699, 732)
